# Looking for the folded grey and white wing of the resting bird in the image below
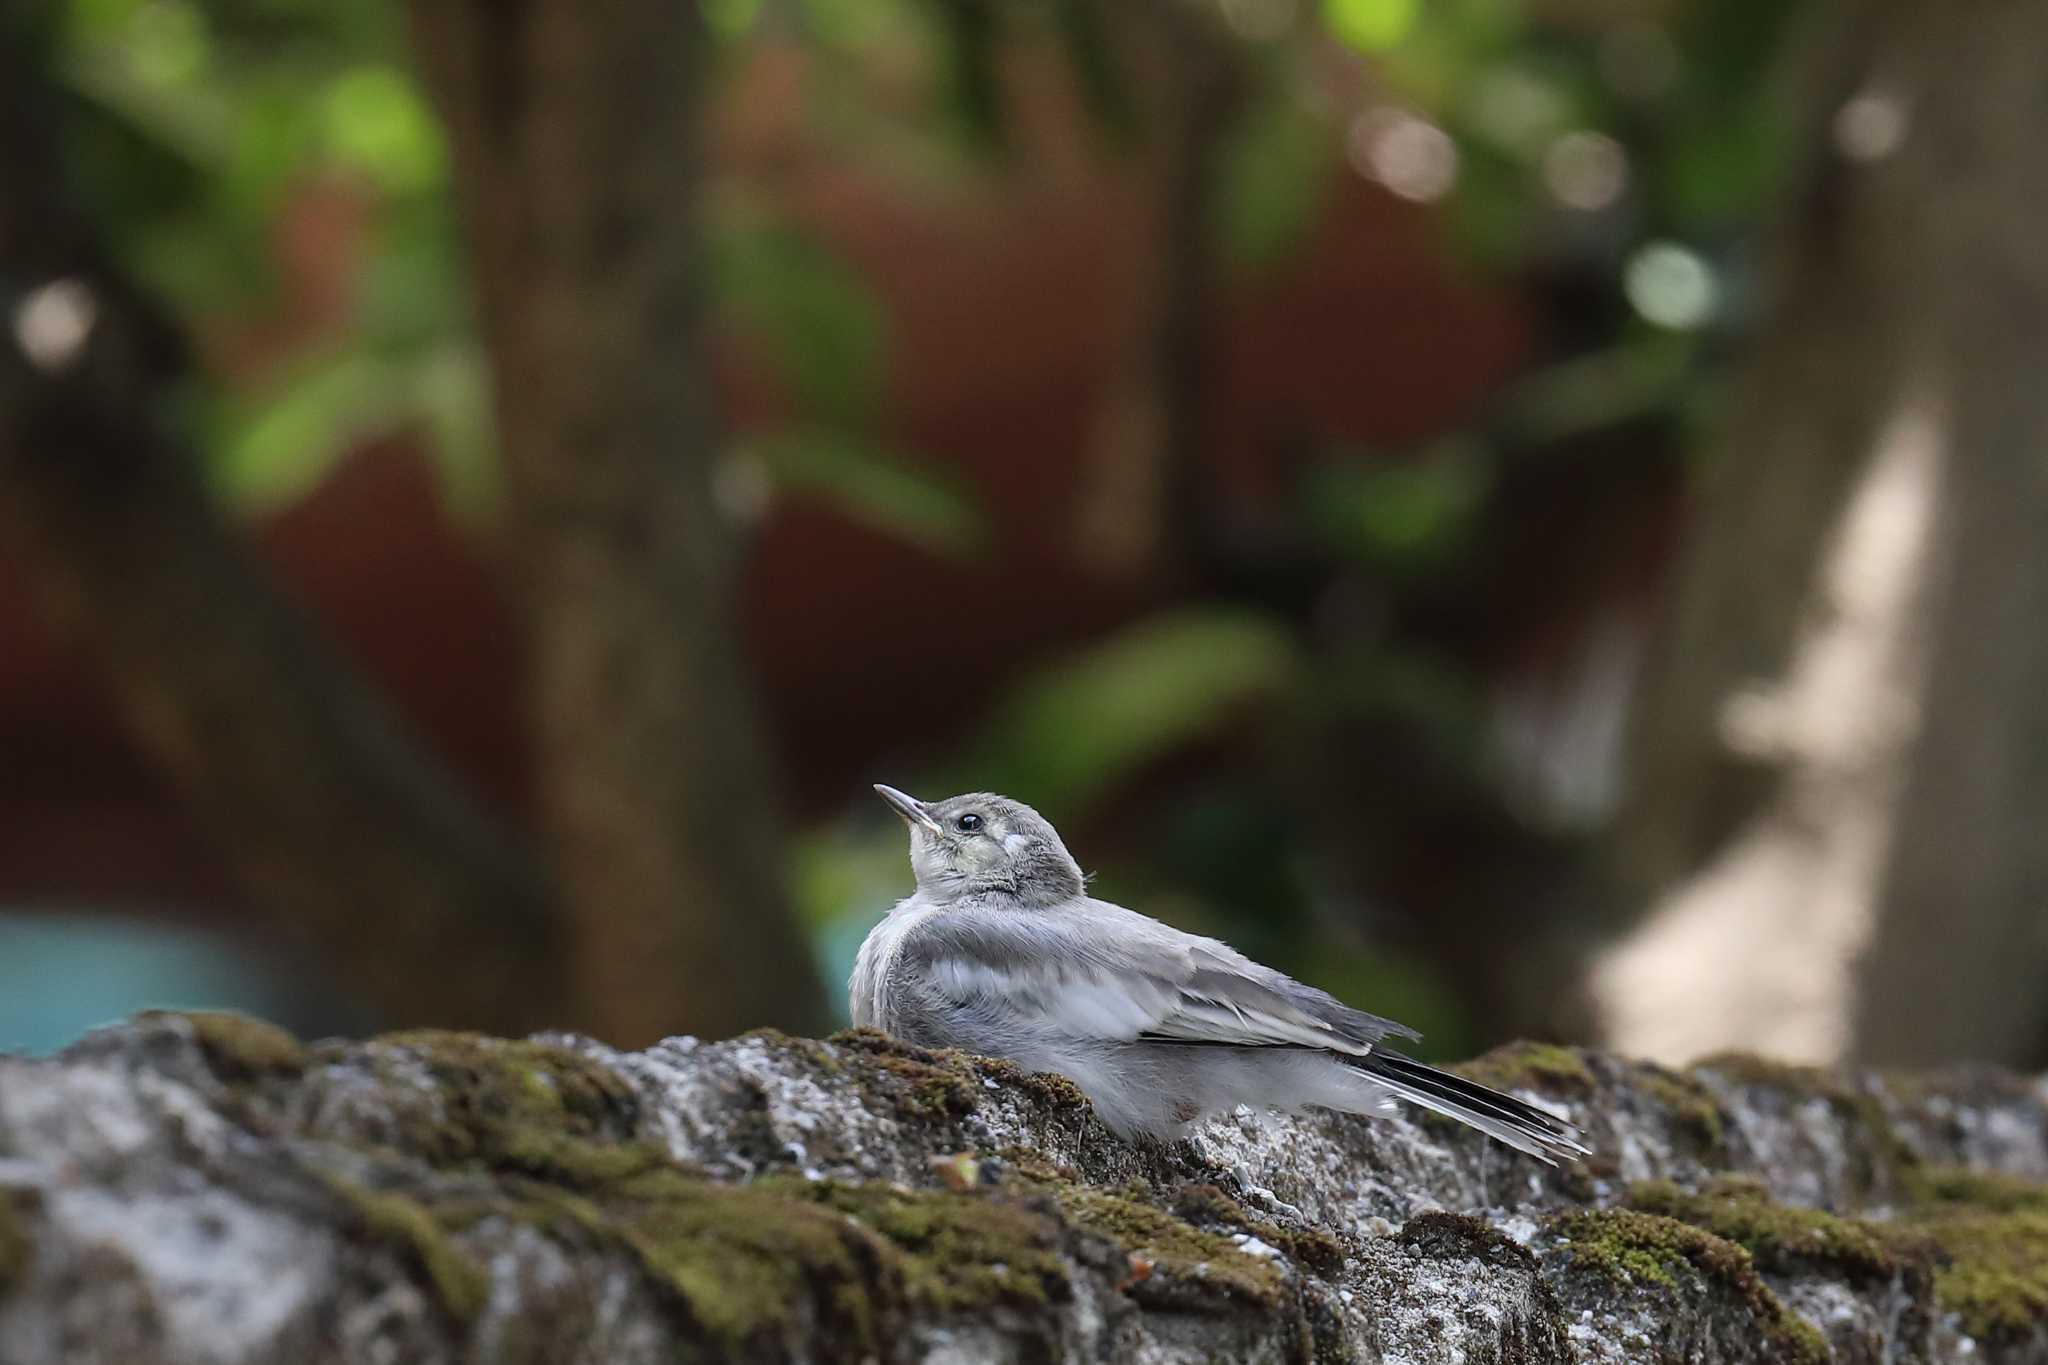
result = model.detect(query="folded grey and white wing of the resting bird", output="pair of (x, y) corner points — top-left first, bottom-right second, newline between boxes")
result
(905, 900), (1415, 1056)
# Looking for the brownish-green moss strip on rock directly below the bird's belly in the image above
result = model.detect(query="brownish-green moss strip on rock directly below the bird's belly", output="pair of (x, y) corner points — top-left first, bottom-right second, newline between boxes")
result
(1057, 1187), (1286, 1310)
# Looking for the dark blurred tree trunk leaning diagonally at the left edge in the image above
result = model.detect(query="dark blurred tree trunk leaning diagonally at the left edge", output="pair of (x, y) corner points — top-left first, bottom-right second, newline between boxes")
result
(0, 39), (563, 1029)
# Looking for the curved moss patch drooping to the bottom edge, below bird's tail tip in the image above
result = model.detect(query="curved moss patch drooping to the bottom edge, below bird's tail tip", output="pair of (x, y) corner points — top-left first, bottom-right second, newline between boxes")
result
(1548, 1209), (1831, 1365)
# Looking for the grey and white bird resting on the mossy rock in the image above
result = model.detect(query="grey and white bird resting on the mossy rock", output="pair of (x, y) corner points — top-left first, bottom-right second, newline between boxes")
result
(848, 786), (1587, 1164)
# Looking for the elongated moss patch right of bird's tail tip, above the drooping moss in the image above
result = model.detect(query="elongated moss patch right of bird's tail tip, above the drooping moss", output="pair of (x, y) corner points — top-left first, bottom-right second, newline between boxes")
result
(1628, 1179), (1925, 1285)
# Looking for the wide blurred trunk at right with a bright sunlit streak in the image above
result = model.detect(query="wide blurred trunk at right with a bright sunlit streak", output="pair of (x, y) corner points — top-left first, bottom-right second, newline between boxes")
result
(1595, 0), (2048, 1062)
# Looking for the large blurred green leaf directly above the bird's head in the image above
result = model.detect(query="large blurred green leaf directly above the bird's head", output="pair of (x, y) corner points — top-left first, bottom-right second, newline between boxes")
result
(961, 608), (1300, 819)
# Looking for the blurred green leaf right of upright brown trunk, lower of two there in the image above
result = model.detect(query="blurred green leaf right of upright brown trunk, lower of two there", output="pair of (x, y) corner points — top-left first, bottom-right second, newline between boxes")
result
(735, 430), (989, 559)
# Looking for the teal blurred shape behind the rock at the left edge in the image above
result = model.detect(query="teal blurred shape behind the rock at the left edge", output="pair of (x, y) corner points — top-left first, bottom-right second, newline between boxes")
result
(0, 911), (336, 1054)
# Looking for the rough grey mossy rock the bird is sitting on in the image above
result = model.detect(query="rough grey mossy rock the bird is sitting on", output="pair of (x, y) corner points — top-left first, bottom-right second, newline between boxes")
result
(0, 1015), (2048, 1365)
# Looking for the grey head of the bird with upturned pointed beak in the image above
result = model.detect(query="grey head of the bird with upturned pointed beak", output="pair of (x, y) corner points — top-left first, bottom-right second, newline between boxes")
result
(874, 786), (1085, 905)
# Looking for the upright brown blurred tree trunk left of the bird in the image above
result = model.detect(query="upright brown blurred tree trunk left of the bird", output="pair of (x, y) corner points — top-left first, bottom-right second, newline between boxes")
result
(414, 0), (823, 1044)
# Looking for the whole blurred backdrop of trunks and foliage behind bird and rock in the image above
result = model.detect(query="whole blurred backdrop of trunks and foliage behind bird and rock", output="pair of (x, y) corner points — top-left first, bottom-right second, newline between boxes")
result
(0, 0), (2048, 1064)
